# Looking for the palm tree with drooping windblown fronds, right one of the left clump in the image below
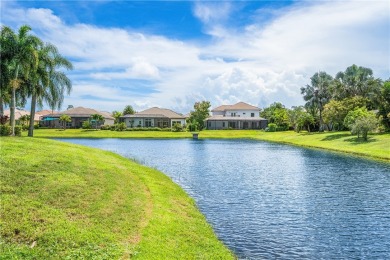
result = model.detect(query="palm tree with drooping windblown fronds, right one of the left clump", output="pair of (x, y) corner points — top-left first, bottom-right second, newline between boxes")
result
(28, 44), (73, 137)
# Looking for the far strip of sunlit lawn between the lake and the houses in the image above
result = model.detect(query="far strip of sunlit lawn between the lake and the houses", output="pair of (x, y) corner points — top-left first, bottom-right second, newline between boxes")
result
(25, 129), (390, 162)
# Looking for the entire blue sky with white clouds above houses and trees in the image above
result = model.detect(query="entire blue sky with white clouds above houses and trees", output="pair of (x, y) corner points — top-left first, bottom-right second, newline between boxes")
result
(1, 1), (390, 113)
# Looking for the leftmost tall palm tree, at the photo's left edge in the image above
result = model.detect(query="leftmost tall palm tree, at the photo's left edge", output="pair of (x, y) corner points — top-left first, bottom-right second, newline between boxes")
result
(1, 25), (41, 136)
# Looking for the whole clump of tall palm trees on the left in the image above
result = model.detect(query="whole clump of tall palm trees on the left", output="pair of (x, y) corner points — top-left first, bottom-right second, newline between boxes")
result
(0, 25), (73, 136)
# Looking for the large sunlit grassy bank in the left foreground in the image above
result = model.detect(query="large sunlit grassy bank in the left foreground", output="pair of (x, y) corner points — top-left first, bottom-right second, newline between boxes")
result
(0, 137), (233, 259)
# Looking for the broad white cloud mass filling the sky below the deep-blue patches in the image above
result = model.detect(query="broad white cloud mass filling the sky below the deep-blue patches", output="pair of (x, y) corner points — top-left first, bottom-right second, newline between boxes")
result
(2, 1), (390, 112)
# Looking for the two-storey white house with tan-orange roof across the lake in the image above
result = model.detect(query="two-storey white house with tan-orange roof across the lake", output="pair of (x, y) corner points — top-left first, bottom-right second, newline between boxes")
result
(206, 102), (268, 130)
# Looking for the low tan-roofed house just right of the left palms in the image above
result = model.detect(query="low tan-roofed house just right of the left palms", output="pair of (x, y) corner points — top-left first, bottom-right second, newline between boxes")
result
(41, 107), (114, 128)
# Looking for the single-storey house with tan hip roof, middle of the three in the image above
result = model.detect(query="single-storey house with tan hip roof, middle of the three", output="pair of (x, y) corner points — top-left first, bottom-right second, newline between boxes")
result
(120, 107), (186, 128)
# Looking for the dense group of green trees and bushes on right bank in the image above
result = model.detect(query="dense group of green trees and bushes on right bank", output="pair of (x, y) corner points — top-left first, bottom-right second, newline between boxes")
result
(260, 65), (390, 139)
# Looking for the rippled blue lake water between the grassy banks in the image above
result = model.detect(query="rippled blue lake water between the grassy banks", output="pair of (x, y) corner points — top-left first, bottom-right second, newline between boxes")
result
(58, 139), (390, 259)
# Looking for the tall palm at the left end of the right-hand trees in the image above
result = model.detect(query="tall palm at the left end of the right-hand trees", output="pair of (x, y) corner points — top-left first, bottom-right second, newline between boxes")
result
(301, 71), (333, 131)
